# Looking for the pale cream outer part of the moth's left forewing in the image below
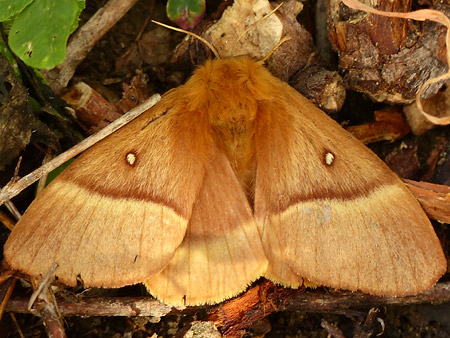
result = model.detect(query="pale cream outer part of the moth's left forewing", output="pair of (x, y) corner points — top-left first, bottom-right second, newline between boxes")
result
(5, 180), (187, 287)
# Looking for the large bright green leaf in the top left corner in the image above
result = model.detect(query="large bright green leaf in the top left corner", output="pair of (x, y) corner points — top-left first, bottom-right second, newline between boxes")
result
(9, 0), (81, 69)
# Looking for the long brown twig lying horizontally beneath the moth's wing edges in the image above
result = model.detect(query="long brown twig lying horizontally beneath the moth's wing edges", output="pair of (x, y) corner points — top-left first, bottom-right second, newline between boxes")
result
(6, 281), (450, 317)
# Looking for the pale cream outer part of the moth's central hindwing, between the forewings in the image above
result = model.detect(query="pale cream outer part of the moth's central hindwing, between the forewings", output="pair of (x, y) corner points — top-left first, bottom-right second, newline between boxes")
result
(145, 221), (268, 305)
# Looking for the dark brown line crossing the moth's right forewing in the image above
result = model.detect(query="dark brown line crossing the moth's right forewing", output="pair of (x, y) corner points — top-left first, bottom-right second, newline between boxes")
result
(271, 176), (401, 213)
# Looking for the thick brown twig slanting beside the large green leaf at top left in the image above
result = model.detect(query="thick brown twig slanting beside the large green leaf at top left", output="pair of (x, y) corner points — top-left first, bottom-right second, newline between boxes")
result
(42, 0), (141, 94)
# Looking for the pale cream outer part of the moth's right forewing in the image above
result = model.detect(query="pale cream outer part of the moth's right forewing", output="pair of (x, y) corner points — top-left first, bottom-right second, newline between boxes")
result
(263, 182), (442, 295)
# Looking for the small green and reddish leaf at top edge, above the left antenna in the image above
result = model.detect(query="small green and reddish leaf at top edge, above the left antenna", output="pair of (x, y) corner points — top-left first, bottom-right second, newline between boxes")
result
(166, 0), (206, 29)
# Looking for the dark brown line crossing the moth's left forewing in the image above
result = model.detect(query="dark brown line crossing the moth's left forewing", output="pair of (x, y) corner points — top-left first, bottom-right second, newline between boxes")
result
(62, 180), (188, 219)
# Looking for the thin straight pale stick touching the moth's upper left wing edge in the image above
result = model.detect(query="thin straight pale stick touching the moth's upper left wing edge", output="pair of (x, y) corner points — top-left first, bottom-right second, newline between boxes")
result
(0, 94), (161, 205)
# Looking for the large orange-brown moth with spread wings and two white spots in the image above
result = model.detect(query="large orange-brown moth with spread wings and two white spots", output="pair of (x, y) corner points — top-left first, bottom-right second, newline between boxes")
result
(4, 57), (446, 305)
